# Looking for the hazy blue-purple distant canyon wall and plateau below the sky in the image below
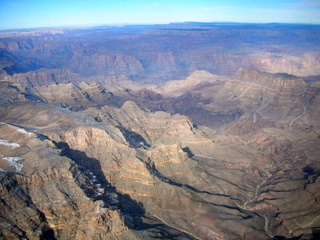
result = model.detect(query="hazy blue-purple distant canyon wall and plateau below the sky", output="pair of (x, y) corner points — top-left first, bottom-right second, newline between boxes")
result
(0, 24), (320, 85)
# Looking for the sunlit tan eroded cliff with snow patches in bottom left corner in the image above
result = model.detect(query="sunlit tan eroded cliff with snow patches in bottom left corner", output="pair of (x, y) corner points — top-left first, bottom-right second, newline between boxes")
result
(0, 123), (144, 239)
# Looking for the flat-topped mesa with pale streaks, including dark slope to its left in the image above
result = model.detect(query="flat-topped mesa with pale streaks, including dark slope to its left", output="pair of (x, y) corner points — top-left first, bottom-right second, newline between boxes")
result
(150, 69), (319, 131)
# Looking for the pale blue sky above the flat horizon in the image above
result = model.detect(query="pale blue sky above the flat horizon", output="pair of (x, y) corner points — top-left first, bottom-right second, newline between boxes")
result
(0, 0), (320, 29)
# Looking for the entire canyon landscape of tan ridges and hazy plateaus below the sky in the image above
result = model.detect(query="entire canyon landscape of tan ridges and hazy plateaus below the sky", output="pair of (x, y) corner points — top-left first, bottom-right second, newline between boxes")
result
(0, 22), (320, 240)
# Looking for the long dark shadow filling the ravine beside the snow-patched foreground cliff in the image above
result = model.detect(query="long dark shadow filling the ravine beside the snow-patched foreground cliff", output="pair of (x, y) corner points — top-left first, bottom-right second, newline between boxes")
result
(53, 142), (194, 239)
